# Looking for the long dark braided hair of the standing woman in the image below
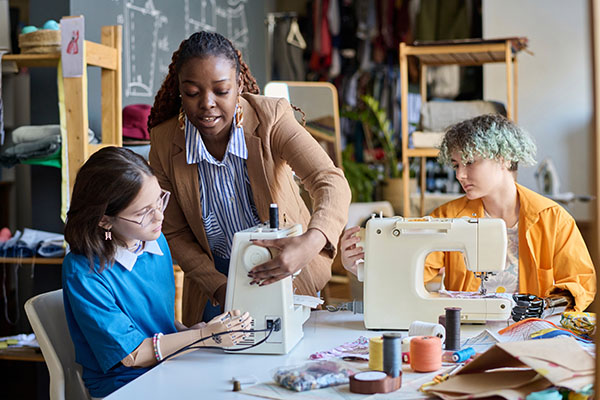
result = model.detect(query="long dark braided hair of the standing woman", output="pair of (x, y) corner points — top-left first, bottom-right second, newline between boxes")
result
(148, 31), (260, 130)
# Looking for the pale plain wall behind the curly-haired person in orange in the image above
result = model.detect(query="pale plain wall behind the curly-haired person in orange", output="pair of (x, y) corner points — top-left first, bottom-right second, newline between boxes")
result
(483, 0), (594, 220)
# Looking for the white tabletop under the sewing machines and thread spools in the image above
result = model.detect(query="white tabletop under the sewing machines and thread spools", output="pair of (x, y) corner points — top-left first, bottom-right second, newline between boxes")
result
(106, 311), (507, 400)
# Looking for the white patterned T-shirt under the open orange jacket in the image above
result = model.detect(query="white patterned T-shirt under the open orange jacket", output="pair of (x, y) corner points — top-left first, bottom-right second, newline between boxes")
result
(485, 212), (519, 293)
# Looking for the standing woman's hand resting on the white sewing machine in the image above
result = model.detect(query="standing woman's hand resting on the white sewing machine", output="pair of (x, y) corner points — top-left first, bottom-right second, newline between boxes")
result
(248, 229), (327, 286)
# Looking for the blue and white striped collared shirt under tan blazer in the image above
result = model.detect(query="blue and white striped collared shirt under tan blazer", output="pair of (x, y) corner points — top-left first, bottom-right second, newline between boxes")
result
(185, 117), (260, 258)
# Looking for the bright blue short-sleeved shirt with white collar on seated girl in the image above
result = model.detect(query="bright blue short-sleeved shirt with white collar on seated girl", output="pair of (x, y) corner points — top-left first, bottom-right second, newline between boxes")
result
(62, 234), (177, 397)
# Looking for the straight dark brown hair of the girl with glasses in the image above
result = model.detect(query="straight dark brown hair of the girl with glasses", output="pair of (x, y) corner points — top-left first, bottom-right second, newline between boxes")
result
(65, 147), (154, 272)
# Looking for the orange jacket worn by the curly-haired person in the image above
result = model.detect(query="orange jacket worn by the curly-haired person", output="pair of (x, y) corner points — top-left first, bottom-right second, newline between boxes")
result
(425, 184), (596, 311)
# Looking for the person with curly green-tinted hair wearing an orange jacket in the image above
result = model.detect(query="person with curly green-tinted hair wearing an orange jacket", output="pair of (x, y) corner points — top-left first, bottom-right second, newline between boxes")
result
(340, 114), (596, 311)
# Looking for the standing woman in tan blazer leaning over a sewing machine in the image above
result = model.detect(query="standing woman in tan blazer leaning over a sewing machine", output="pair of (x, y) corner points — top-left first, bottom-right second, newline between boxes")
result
(148, 32), (350, 325)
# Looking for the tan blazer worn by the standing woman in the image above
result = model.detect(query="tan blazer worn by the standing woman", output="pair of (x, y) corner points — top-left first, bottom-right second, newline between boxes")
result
(150, 94), (350, 326)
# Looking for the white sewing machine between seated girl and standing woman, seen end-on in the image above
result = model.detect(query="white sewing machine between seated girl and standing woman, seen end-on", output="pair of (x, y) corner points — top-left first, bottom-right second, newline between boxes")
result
(225, 223), (310, 354)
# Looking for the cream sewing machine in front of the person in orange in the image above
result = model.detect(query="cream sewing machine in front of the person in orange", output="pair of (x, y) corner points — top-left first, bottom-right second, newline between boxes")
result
(358, 217), (511, 329)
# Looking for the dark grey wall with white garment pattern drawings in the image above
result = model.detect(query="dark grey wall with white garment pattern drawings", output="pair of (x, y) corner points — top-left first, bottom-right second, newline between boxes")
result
(70, 0), (271, 132)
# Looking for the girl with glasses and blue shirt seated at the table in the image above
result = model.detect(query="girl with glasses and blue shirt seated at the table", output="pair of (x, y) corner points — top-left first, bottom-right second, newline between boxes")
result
(62, 147), (252, 397)
